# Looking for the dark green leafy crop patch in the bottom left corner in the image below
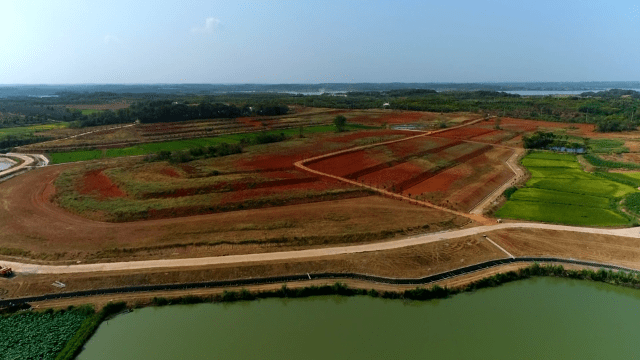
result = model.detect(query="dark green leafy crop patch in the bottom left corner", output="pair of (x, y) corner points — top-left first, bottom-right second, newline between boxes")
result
(0, 309), (92, 359)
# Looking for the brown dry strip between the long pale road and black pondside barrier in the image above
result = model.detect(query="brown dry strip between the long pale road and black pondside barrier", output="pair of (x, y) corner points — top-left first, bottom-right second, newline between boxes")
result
(0, 236), (504, 298)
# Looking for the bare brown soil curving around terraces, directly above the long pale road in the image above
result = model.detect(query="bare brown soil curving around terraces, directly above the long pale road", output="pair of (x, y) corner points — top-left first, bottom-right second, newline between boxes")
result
(0, 164), (468, 263)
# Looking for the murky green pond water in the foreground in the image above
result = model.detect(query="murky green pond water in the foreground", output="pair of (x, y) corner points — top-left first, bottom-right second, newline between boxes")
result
(78, 278), (640, 360)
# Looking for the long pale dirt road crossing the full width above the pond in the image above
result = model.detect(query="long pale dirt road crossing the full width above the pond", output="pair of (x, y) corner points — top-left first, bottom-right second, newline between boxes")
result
(5, 223), (640, 274)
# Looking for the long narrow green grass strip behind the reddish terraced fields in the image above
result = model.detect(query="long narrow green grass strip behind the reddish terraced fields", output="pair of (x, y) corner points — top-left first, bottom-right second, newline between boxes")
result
(49, 124), (375, 164)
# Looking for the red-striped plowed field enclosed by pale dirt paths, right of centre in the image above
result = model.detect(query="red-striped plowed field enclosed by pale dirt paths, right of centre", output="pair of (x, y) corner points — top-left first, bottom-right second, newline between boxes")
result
(307, 126), (513, 211)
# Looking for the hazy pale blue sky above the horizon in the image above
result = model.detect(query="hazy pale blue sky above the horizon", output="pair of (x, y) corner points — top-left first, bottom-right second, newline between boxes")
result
(0, 0), (640, 84)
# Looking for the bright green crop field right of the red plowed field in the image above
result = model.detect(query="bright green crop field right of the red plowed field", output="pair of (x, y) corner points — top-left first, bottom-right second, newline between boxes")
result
(495, 153), (640, 226)
